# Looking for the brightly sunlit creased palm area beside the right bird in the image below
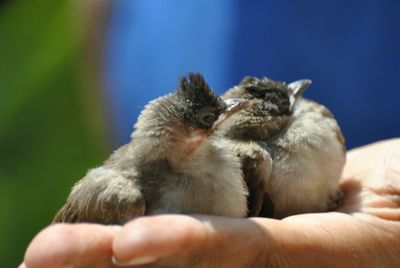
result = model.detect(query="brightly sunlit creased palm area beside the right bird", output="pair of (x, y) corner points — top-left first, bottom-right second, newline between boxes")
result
(338, 139), (400, 216)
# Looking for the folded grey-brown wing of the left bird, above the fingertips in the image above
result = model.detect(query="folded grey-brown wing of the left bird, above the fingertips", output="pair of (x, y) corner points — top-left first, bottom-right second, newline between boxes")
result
(53, 167), (146, 224)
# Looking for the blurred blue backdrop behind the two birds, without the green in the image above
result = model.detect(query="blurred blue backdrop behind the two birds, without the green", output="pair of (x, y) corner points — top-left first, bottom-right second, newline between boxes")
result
(105, 0), (400, 148)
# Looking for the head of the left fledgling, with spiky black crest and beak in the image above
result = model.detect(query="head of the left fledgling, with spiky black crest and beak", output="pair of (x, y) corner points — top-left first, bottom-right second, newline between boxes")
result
(132, 73), (250, 161)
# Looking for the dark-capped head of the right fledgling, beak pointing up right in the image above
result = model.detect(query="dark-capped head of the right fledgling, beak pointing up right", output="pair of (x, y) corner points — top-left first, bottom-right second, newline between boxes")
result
(223, 76), (311, 138)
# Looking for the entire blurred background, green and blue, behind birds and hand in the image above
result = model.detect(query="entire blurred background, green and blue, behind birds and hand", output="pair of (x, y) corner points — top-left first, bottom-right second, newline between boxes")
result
(0, 0), (400, 267)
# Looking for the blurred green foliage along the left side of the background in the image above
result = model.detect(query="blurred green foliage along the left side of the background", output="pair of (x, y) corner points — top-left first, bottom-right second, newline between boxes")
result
(0, 0), (106, 267)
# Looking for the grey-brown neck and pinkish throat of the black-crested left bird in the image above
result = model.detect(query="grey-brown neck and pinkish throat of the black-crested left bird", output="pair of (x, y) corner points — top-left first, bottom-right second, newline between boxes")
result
(132, 94), (223, 170)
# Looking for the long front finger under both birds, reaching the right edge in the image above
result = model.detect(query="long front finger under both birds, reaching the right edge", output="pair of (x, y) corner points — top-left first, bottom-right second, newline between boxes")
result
(113, 213), (399, 267)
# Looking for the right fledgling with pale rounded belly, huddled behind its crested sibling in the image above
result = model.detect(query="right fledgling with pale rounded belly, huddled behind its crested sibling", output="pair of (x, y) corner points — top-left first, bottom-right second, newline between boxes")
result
(223, 77), (346, 218)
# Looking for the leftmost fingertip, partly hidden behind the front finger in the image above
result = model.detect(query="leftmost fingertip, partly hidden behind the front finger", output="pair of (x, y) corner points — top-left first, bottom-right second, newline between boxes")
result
(25, 224), (120, 268)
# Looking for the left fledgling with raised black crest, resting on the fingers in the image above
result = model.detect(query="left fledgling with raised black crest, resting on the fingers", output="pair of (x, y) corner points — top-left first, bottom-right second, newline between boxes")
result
(54, 73), (249, 224)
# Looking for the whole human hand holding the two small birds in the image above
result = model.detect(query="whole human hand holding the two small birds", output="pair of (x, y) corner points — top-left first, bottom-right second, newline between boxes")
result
(20, 139), (400, 268)
